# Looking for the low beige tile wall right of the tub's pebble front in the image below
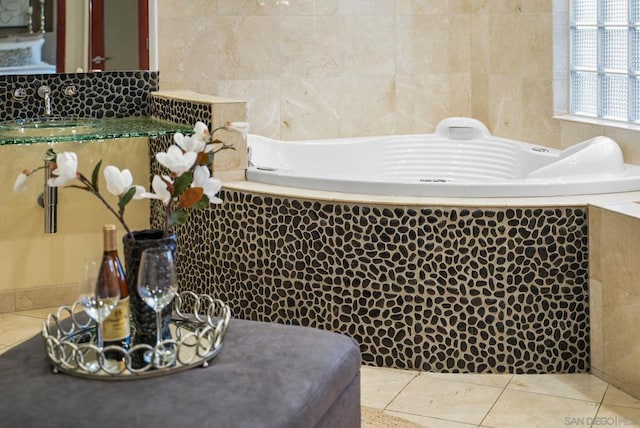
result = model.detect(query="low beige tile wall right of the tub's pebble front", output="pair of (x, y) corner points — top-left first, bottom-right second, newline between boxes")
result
(589, 207), (640, 397)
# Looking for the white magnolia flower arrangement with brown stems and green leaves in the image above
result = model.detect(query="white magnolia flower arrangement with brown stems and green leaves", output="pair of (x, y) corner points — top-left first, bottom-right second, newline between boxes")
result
(13, 122), (249, 236)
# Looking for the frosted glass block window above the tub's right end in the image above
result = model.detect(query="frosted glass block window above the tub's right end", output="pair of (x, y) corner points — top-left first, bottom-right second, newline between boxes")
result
(569, 0), (640, 123)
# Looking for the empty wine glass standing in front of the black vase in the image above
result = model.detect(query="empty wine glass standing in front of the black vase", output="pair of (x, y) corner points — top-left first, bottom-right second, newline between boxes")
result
(138, 247), (178, 367)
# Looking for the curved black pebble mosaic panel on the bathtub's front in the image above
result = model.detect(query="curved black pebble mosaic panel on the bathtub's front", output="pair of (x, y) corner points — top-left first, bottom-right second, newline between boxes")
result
(164, 191), (589, 373)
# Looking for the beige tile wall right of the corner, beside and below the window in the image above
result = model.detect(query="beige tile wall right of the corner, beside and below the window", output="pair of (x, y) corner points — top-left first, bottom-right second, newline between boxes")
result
(471, 0), (640, 157)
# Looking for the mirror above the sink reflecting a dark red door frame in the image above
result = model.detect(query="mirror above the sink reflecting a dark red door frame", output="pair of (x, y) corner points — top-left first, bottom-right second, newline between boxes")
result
(0, 0), (158, 75)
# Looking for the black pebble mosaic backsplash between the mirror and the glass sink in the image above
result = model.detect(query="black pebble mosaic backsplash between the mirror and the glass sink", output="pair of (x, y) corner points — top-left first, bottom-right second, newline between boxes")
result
(0, 71), (159, 120)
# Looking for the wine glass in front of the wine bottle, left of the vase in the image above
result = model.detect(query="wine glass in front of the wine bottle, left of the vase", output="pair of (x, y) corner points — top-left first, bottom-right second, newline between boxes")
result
(79, 260), (120, 371)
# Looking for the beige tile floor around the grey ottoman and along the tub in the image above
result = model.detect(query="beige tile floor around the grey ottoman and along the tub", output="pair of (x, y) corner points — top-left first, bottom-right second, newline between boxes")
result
(0, 308), (640, 428)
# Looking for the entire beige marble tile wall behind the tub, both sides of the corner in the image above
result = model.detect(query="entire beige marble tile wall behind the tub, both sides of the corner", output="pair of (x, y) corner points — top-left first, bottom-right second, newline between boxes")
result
(159, 0), (640, 159)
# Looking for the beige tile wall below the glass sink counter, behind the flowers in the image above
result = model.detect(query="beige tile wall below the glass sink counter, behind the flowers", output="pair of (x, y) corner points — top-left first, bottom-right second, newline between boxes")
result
(0, 138), (149, 312)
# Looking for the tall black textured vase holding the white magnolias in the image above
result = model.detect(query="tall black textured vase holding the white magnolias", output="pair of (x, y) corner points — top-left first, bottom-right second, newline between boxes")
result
(122, 230), (177, 367)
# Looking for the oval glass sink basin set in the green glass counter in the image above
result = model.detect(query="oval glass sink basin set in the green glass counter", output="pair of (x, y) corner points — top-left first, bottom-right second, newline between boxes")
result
(0, 117), (103, 139)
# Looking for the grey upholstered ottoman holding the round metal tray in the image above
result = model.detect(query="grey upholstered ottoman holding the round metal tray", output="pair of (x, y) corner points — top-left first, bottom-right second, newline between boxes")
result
(0, 319), (360, 428)
